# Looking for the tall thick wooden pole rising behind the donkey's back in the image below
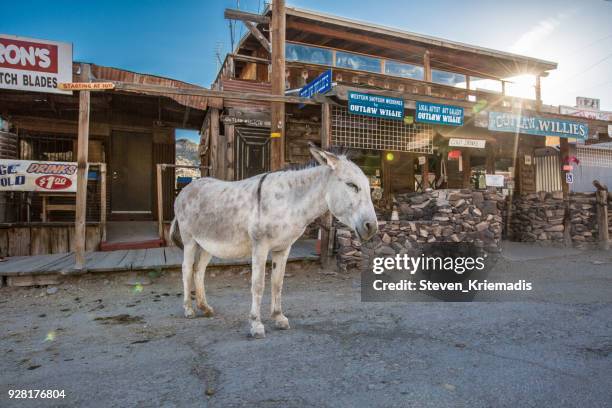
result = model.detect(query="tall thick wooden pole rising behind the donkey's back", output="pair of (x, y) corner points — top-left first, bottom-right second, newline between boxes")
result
(270, 0), (285, 170)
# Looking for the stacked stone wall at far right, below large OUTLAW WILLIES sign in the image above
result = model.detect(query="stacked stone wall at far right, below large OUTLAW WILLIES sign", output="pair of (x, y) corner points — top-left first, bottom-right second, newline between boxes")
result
(509, 191), (612, 246)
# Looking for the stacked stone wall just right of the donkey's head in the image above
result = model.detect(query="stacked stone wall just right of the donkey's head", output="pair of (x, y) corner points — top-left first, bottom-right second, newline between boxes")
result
(336, 190), (504, 271)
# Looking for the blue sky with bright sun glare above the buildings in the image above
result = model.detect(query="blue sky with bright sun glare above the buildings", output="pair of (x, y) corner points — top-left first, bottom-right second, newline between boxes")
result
(0, 0), (612, 143)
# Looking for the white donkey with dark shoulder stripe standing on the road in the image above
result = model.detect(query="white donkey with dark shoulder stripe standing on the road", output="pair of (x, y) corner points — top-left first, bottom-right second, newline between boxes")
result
(170, 144), (378, 338)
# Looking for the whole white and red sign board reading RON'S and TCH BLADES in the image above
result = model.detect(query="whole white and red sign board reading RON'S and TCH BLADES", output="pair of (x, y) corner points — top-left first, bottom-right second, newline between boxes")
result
(0, 34), (72, 94)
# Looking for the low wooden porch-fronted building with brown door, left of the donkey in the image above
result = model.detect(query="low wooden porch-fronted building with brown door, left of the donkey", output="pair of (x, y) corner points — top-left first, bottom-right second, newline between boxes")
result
(0, 63), (210, 256)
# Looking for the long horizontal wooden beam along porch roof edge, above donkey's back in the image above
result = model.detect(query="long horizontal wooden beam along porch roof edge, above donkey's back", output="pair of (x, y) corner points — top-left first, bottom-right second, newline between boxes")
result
(115, 81), (319, 105)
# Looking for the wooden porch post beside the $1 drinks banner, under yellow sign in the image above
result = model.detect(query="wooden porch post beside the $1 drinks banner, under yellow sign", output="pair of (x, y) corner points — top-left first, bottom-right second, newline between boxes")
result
(74, 64), (91, 270)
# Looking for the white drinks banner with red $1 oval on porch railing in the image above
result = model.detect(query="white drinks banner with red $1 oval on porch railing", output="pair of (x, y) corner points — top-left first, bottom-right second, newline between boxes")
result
(0, 159), (77, 193)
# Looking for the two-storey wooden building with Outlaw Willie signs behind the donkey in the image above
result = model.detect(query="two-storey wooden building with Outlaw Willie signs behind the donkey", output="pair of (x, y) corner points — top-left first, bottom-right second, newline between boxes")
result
(209, 1), (608, 196)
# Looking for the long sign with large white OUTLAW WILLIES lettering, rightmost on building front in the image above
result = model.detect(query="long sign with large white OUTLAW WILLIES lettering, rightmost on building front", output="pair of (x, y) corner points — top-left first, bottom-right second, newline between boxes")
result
(489, 112), (589, 139)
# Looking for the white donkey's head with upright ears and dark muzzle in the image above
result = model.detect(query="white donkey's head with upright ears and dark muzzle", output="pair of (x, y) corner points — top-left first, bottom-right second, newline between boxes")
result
(310, 143), (378, 241)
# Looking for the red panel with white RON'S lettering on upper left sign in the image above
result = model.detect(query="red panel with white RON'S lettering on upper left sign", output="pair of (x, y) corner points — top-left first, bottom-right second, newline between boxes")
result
(0, 38), (58, 74)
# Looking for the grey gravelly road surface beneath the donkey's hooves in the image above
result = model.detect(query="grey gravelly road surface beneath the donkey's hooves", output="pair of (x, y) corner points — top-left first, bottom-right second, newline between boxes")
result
(0, 251), (612, 407)
